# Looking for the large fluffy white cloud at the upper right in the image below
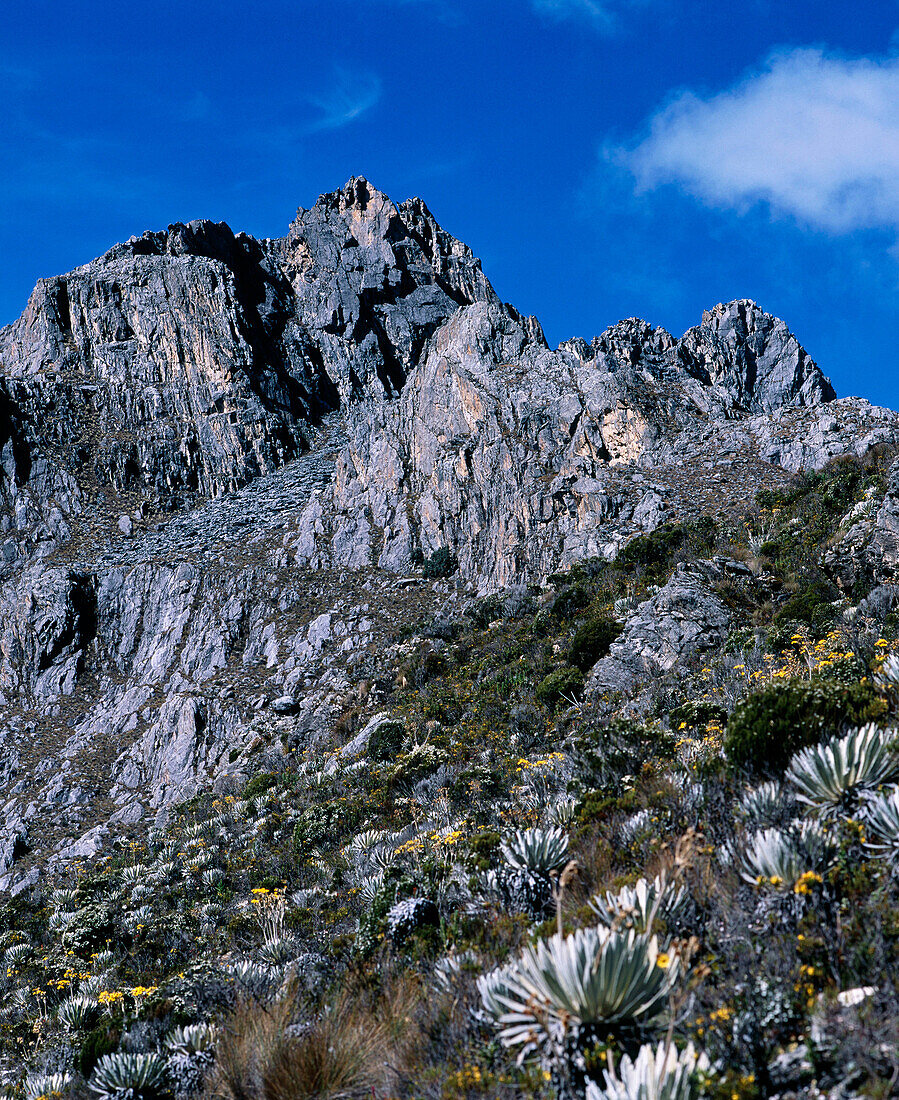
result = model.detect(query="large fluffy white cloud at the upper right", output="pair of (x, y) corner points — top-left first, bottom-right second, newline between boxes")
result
(606, 50), (899, 232)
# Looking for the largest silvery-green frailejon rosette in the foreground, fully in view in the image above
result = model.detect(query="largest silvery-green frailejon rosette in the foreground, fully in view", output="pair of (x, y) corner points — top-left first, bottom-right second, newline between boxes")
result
(478, 928), (679, 1068)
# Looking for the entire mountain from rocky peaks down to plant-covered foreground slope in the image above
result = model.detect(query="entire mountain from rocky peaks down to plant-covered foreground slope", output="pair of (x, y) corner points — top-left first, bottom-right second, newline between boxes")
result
(0, 180), (899, 1100)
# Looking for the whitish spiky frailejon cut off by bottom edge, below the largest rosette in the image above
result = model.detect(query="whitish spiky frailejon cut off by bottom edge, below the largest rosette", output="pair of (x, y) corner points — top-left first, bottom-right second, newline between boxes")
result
(586, 1041), (709, 1100)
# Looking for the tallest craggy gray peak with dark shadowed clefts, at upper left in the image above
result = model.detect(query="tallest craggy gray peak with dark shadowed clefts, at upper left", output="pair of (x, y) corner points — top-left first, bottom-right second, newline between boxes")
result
(0, 179), (496, 501)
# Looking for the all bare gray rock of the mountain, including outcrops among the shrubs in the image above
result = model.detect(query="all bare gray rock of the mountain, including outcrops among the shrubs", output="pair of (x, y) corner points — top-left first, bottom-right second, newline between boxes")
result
(0, 178), (899, 890)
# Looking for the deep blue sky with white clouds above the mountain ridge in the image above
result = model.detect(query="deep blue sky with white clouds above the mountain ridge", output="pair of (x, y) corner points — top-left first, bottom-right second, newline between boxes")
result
(0, 0), (899, 407)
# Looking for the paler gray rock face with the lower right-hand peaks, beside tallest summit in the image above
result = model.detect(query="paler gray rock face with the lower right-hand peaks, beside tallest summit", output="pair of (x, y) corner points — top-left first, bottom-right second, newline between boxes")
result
(316, 301), (884, 586)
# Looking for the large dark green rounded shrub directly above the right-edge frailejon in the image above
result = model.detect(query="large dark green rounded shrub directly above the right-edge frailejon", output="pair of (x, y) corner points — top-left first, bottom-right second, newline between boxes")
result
(724, 679), (884, 777)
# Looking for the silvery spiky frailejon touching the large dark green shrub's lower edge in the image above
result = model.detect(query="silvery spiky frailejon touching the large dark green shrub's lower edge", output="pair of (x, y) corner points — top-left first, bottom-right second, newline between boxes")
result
(787, 725), (899, 816)
